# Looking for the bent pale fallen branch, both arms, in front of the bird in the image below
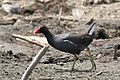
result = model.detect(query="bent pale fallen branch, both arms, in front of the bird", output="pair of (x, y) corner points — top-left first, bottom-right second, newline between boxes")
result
(12, 34), (49, 80)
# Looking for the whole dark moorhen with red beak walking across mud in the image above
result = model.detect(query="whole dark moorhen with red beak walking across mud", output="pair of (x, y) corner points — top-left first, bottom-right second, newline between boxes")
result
(35, 22), (96, 71)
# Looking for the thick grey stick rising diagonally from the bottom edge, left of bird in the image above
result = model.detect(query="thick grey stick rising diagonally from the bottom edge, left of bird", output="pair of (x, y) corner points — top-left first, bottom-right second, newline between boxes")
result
(21, 46), (49, 80)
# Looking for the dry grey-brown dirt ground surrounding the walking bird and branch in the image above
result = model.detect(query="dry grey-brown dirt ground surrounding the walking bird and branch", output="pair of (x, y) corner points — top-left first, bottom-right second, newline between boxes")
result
(0, 0), (120, 80)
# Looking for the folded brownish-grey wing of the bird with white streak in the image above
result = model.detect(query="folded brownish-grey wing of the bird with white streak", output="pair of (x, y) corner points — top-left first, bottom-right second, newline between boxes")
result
(55, 33), (92, 49)
